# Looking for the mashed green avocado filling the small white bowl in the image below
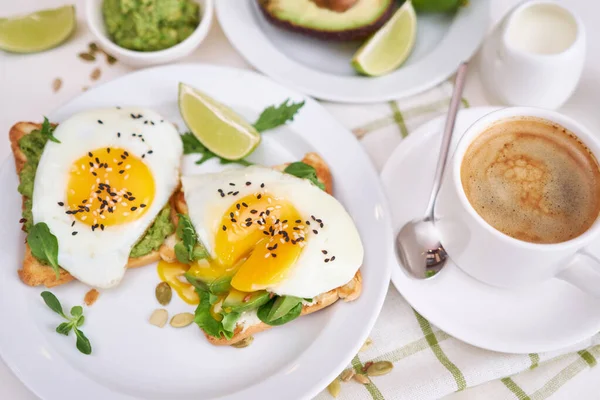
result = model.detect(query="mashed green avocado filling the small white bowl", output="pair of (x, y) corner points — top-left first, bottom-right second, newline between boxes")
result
(102, 0), (200, 51)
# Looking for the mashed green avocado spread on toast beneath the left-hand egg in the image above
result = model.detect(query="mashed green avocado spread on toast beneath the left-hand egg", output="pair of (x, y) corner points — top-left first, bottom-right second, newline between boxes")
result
(19, 127), (175, 258)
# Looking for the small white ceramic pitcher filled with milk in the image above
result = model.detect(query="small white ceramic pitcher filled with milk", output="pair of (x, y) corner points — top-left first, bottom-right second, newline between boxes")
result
(479, 0), (586, 109)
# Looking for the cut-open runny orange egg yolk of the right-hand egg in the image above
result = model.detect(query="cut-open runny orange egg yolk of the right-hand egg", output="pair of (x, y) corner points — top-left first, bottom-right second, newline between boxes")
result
(211, 194), (310, 292)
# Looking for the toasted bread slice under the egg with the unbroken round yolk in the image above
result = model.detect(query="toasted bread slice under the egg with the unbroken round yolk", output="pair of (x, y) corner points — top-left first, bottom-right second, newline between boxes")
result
(9, 122), (175, 288)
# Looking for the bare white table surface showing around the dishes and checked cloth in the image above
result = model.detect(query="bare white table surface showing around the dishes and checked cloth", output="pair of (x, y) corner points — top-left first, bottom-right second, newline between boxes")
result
(0, 0), (600, 400)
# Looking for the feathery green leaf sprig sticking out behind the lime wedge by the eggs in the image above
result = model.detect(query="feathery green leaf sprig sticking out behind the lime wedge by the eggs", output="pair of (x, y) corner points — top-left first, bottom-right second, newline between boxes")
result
(181, 99), (304, 166)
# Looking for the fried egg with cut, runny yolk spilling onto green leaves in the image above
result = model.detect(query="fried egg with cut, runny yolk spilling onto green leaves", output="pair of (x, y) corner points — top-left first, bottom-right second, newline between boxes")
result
(182, 166), (364, 298)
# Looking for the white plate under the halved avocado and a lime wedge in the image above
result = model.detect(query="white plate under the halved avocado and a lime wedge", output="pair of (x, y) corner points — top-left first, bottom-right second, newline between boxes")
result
(216, 0), (490, 103)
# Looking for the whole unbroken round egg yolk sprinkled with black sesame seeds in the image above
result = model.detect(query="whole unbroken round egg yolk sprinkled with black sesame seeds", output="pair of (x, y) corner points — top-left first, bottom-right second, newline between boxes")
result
(66, 147), (155, 230)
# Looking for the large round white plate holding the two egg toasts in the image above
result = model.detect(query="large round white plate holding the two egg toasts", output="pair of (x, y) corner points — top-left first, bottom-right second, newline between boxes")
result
(0, 65), (392, 400)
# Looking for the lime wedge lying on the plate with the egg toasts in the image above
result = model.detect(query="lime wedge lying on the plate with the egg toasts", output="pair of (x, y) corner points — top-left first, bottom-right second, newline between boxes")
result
(179, 83), (260, 160)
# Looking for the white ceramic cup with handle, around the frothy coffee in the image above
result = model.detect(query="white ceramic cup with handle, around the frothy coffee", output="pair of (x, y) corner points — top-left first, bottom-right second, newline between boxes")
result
(435, 107), (600, 297)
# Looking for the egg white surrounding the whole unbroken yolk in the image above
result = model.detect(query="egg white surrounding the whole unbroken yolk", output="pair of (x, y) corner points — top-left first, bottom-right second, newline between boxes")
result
(32, 107), (183, 288)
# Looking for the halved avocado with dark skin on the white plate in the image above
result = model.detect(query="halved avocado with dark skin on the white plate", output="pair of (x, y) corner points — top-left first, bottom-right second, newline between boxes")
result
(258, 0), (396, 41)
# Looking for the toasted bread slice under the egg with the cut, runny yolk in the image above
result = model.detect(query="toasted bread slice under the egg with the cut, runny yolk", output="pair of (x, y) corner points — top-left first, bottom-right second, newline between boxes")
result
(170, 153), (362, 346)
